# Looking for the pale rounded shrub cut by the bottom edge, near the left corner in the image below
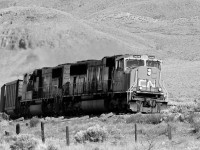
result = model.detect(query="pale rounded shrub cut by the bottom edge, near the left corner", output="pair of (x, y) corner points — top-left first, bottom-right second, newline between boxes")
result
(10, 134), (38, 150)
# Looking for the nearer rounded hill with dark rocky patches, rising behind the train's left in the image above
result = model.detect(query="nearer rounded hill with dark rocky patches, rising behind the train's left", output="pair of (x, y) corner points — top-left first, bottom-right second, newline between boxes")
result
(0, 7), (131, 82)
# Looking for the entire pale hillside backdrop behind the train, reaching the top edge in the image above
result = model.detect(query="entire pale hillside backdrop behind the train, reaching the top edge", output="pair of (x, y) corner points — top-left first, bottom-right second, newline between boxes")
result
(0, 0), (200, 101)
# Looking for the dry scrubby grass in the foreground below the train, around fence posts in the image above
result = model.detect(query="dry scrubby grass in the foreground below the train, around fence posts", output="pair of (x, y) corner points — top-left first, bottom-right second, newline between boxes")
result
(0, 114), (199, 150)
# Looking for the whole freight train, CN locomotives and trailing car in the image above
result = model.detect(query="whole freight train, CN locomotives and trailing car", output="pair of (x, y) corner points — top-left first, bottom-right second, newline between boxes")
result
(0, 54), (167, 117)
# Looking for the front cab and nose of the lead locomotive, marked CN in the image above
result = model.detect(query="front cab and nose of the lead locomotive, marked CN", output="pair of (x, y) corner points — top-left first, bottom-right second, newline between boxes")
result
(115, 55), (167, 112)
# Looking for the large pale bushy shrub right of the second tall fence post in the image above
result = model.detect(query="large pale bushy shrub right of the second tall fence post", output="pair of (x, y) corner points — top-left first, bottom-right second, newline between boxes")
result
(74, 125), (108, 143)
